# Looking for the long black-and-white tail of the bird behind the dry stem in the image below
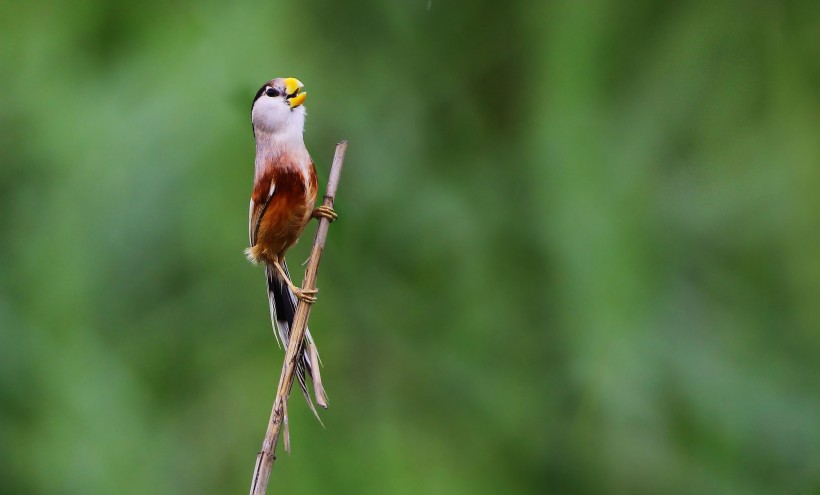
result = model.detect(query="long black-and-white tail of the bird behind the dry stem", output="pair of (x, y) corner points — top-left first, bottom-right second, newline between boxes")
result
(265, 261), (327, 418)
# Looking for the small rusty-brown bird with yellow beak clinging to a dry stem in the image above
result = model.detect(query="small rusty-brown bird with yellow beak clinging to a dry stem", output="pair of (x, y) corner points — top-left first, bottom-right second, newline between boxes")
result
(245, 77), (337, 417)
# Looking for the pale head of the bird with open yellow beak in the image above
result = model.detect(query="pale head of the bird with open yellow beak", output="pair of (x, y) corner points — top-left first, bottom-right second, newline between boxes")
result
(251, 77), (307, 134)
